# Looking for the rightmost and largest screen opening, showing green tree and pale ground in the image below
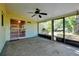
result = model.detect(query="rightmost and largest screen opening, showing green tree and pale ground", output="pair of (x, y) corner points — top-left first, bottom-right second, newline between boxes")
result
(65, 16), (79, 41)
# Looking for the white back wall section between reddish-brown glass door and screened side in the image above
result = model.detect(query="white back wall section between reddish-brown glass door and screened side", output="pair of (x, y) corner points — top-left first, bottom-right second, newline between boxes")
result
(26, 23), (37, 38)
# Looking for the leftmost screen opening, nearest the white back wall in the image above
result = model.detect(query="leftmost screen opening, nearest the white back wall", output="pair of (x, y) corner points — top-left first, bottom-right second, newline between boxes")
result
(39, 21), (52, 35)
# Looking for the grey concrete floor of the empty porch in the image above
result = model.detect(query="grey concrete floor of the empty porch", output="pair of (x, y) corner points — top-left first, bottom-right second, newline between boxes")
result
(2, 37), (79, 56)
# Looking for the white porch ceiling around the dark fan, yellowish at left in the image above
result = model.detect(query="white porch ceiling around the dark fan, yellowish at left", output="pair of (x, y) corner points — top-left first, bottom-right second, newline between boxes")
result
(6, 3), (79, 21)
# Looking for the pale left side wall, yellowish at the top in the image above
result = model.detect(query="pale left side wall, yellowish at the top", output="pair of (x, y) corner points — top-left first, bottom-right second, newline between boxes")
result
(0, 4), (6, 52)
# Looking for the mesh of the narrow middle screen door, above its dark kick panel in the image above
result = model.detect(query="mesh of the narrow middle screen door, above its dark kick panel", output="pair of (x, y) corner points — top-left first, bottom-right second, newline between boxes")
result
(54, 19), (63, 40)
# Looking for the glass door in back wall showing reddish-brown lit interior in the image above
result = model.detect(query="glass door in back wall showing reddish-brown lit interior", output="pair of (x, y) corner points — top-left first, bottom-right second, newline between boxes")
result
(10, 19), (26, 40)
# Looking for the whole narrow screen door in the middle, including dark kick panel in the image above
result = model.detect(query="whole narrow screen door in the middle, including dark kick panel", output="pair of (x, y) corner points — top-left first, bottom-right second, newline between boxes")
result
(53, 18), (65, 42)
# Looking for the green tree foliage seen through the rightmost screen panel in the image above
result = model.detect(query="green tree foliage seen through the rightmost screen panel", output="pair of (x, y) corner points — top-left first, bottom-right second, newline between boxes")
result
(65, 16), (76, 32)
